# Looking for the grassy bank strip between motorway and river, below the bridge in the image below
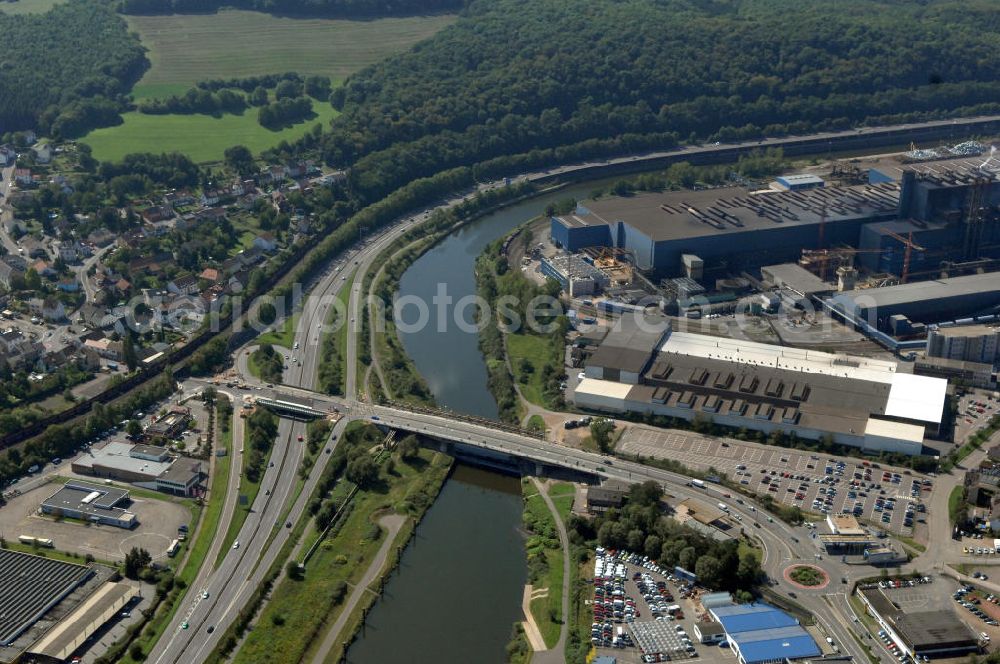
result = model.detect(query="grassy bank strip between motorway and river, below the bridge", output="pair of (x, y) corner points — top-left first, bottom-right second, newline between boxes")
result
(234, 425), (451, 663)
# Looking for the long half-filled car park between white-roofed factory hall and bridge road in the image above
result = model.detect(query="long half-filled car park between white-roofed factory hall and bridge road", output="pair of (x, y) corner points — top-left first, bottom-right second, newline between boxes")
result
(618, 426), (934, 536)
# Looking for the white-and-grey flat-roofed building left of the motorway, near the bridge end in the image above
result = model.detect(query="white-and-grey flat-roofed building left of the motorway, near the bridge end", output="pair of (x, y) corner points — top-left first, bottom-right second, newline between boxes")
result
(72, 442), (204, 496)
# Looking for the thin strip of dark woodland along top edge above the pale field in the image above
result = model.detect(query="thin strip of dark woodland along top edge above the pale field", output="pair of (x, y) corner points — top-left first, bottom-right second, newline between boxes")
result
(120, 0), (465, 17)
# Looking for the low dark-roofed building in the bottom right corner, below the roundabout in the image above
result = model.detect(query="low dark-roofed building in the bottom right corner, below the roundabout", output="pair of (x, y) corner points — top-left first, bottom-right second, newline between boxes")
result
(858, 586), (979, 660)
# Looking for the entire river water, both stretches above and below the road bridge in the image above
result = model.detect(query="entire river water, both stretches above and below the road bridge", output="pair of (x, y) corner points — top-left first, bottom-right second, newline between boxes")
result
(347, 181), (607, 664)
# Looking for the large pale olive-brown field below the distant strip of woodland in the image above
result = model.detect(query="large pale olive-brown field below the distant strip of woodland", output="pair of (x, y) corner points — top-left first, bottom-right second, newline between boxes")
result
(125, 9), (455, 97)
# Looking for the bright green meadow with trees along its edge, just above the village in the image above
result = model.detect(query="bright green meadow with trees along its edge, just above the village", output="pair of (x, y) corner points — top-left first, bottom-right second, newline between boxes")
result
(81, 103), (337, 163)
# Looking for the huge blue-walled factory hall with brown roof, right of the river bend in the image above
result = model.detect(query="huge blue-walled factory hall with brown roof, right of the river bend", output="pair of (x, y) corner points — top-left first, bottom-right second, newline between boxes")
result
(551, 183), (898, 276)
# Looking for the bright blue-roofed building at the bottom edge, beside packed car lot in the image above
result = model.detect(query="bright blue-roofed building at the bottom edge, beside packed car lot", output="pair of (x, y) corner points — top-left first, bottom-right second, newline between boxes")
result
(708, 603), (821, 664)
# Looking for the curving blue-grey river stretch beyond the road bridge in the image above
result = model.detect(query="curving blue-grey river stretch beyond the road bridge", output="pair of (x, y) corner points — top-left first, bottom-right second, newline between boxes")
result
(399, 180), (611, 419)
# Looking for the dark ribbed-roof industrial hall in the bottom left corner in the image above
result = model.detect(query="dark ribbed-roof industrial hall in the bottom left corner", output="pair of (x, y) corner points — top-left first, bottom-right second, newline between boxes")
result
(0, 549), (93, 646)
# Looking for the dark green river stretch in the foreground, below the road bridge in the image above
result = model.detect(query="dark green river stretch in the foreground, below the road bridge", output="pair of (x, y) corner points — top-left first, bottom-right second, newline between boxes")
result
(347, 465), (527, 664)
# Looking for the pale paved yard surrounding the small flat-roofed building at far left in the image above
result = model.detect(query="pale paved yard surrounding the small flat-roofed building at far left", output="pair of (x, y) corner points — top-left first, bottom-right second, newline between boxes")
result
(0, 478), (191, 562)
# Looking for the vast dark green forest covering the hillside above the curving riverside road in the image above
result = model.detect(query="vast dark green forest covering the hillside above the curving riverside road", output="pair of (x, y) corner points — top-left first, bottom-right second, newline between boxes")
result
(276, 0), (1000, 201)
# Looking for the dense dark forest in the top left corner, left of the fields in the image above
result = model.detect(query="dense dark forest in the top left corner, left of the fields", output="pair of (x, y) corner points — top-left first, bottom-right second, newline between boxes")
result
(0, 0), (147, 138)
